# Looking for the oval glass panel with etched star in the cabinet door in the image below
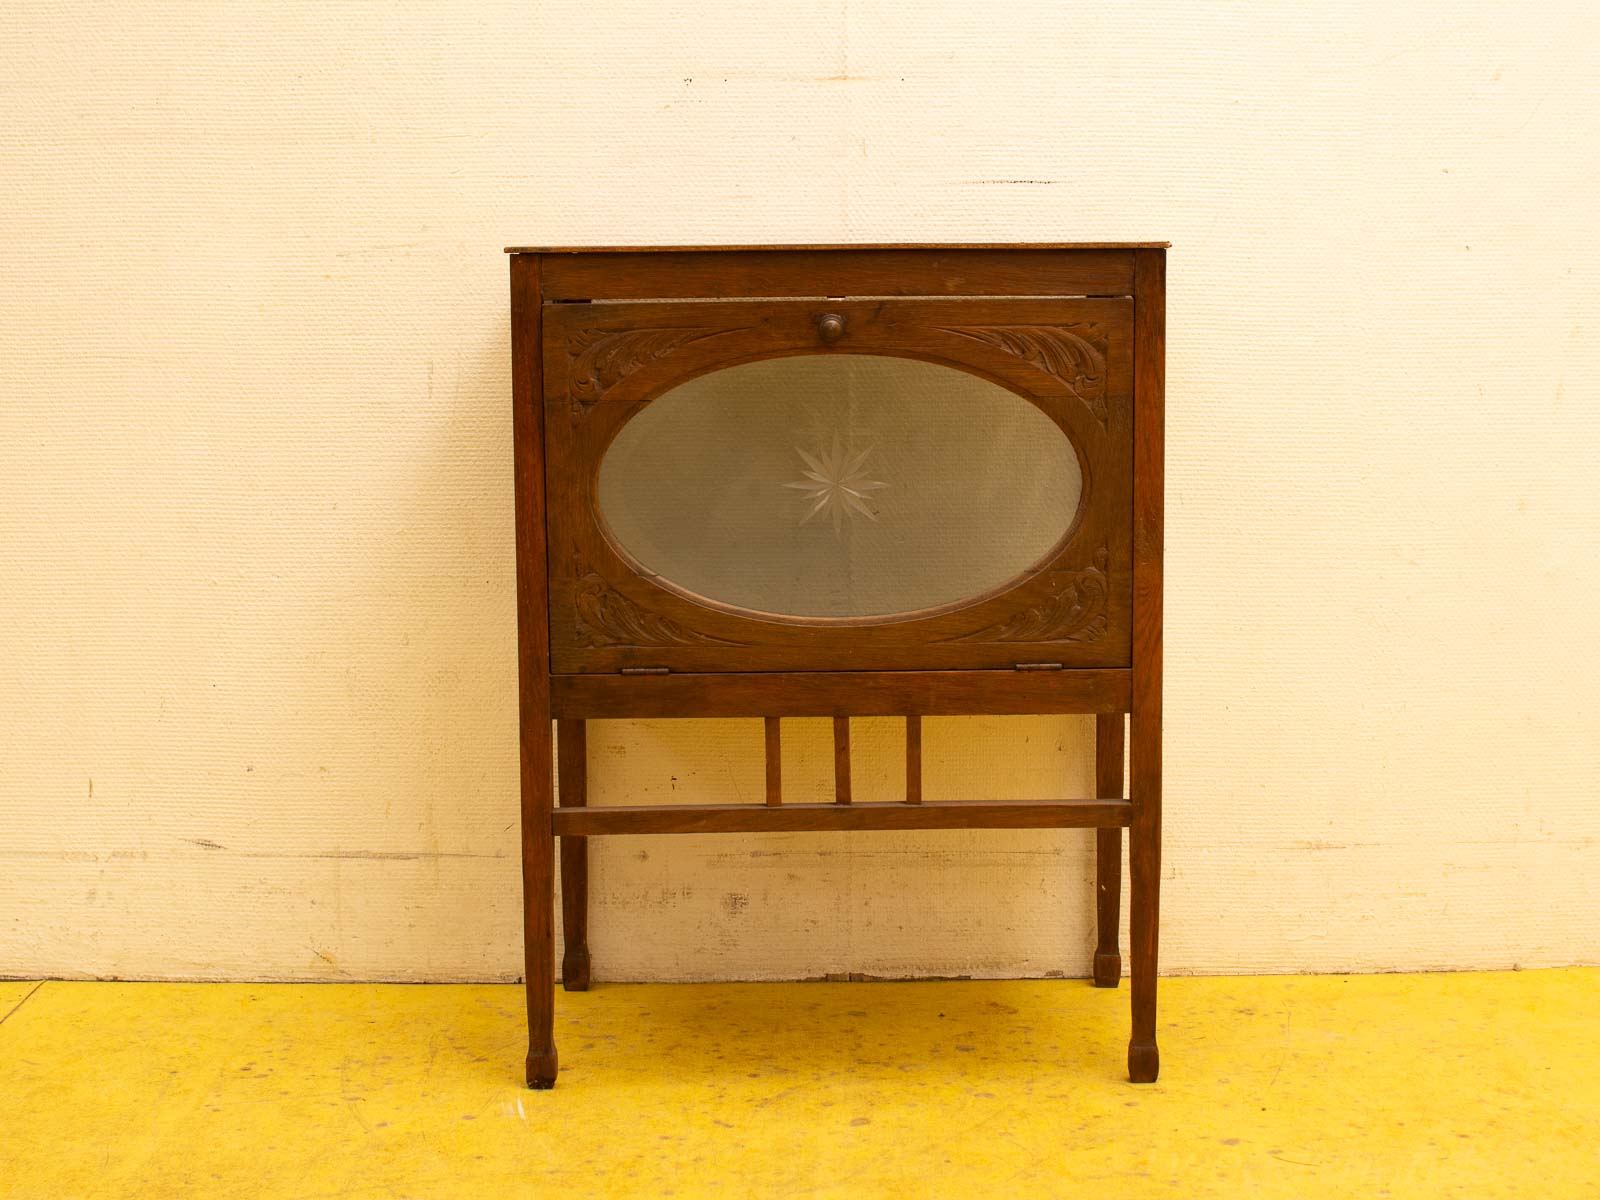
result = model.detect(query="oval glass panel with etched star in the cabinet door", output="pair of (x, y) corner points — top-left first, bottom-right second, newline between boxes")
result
(600, 354), (1083, 618)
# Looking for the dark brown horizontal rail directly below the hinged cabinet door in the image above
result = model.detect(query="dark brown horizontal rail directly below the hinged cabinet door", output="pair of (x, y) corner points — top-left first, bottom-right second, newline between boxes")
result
(550, 670), (1133, 718)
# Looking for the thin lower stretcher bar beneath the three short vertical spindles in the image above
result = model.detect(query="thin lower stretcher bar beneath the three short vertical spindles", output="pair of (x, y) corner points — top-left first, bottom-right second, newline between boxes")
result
(555, 798), (1133, 837)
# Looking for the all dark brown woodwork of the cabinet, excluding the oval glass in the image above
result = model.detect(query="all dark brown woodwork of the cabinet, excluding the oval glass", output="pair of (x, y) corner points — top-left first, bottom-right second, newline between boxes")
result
(512, 243), (1165, 1086)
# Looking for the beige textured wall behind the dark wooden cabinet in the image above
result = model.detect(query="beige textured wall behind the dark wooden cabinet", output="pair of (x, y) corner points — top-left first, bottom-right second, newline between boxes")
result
(0, 0), (1600, 979)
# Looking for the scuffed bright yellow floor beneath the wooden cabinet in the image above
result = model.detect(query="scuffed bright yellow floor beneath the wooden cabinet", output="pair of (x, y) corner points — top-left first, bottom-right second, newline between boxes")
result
(0, 970), (1600, 1200)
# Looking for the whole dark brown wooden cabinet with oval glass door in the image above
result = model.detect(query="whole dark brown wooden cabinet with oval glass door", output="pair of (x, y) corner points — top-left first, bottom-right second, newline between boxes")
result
(510, 243), (1165, 1086)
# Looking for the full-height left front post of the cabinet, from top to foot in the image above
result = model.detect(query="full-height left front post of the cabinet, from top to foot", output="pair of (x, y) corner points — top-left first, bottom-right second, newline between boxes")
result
(510, 256), (557, 1088)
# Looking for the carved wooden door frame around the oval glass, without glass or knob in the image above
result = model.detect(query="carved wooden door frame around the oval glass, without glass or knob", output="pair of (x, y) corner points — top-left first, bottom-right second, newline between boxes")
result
(542, 298), (1134, 674)
